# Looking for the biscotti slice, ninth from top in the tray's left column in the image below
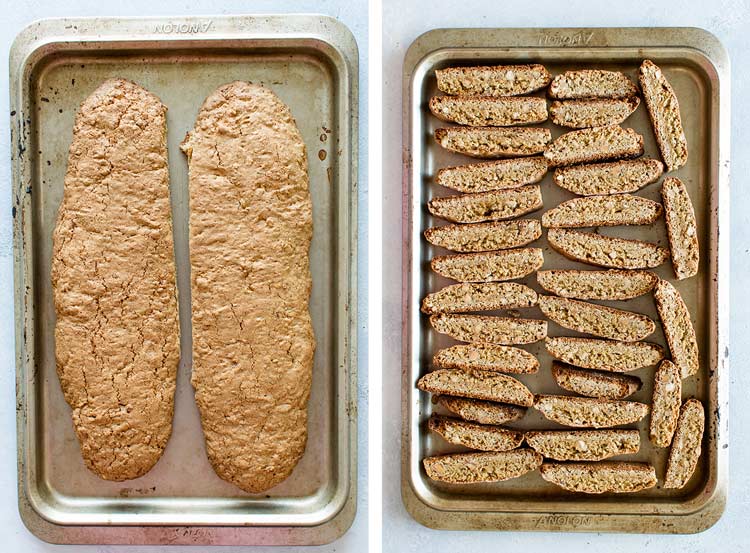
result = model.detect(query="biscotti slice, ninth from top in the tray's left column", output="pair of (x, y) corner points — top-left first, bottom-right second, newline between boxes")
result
(430, 313), (547, 345)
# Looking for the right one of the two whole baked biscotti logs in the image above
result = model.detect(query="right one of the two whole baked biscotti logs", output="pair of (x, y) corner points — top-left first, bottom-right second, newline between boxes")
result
(181, 81), (315, 493)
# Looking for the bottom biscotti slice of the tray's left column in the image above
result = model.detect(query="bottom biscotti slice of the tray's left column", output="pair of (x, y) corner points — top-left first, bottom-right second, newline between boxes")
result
(422, 449), (542, 484)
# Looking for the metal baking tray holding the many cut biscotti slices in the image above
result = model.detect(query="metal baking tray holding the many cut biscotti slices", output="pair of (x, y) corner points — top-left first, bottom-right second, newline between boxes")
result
(402, 28), (729, 533)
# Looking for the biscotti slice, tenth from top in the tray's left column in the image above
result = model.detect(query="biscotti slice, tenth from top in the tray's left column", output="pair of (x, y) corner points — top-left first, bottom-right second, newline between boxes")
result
(432, 344), (539, 373)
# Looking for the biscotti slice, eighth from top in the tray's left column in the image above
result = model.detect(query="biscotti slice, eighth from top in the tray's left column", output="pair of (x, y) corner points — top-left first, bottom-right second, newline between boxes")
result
(422, 282), (537, 314)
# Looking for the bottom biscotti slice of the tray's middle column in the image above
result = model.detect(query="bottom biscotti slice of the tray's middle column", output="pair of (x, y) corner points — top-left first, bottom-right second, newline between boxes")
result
(541, 462), (656, 494)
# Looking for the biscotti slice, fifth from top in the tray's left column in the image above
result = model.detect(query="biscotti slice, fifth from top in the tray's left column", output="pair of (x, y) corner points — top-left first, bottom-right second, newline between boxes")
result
(427, 184), (542, 223)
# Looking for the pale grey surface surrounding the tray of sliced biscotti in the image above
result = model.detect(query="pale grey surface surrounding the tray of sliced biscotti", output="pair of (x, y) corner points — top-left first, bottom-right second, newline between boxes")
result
(383, 0), (750, 553)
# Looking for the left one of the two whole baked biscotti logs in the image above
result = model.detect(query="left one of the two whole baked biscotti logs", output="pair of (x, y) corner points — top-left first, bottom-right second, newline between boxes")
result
(52, 79), (179, 481)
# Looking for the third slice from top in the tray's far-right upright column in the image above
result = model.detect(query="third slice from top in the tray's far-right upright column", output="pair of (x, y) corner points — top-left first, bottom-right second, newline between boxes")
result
(654, 280), (700, 378)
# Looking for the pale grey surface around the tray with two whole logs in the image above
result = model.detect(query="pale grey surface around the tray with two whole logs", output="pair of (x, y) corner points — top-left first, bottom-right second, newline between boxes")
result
(0, 0), (368, 553)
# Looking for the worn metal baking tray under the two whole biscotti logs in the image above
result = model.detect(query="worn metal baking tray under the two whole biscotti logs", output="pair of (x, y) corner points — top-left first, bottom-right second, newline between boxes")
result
(10, 15), (358, 544)
